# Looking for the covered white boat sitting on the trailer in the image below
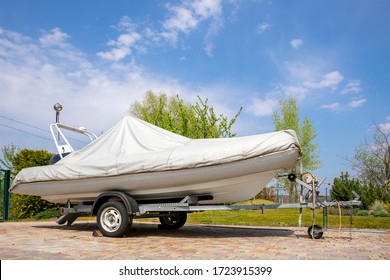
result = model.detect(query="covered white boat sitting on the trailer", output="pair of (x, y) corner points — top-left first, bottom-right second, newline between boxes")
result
(10, 116), (301, 205)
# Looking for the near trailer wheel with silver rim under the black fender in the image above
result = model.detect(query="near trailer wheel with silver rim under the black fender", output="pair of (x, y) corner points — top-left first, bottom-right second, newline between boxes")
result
(96, 201), (130, 237)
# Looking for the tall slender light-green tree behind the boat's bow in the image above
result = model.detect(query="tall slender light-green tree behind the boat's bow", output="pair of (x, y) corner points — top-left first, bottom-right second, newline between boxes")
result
(272, 98), (321, 201)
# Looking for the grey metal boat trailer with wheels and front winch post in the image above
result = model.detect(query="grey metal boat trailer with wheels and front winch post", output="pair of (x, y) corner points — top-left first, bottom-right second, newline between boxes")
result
(57, 173), (361, 239)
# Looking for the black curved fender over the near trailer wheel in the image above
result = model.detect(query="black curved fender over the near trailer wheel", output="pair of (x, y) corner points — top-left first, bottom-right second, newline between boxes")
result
(92, 191), (139, 216)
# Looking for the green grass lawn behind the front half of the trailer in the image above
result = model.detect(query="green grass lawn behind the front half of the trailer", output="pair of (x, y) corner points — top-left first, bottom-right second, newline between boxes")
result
(188, 200), (390, 229)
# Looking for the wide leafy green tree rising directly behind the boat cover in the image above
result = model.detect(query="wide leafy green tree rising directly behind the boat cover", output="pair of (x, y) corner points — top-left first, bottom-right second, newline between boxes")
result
(129, 91), (242, 138)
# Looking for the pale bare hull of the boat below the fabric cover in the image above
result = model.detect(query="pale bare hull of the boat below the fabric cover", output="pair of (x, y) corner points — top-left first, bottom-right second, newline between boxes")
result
(12, 149), (300, 204)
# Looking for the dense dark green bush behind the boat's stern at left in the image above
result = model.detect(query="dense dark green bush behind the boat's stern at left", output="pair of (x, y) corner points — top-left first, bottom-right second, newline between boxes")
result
(11, 149), (54, 219)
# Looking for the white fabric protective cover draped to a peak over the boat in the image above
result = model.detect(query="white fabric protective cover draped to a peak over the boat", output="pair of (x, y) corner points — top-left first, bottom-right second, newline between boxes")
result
(11, 116), (300, 190)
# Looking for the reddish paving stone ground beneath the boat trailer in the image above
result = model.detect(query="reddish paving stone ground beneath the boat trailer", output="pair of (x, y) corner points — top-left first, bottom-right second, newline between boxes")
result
(0, 221), (390, 260)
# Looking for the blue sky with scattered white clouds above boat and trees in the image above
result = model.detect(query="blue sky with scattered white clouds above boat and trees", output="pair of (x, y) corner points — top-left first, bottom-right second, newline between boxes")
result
(0, 0), (390, 190)
